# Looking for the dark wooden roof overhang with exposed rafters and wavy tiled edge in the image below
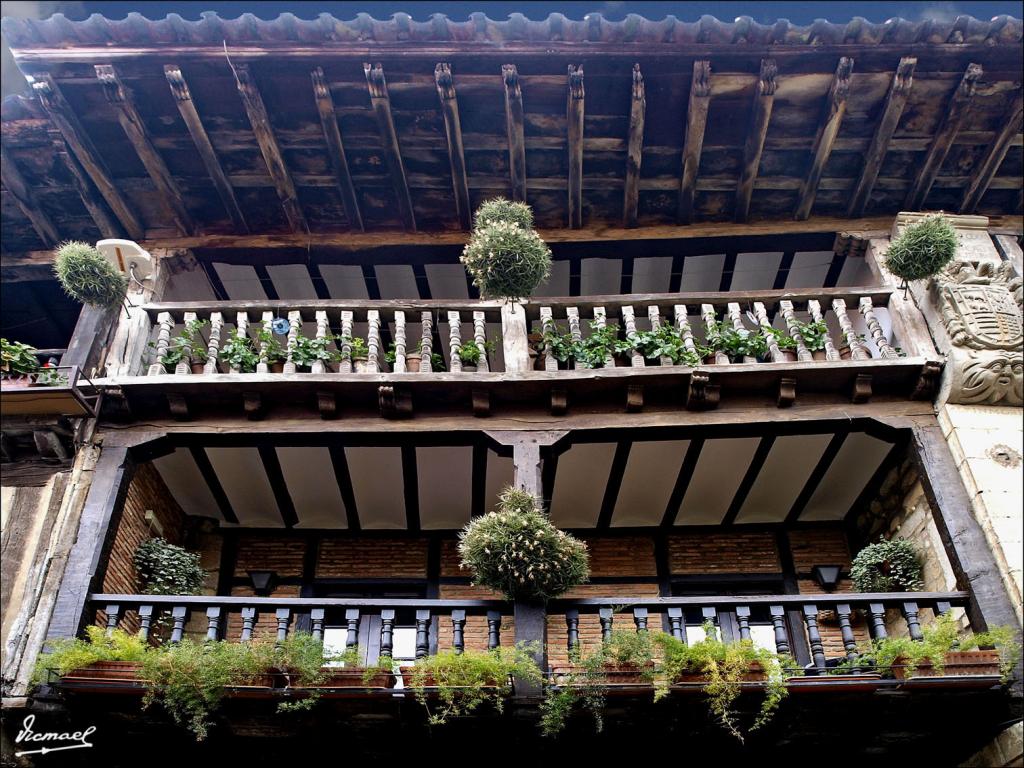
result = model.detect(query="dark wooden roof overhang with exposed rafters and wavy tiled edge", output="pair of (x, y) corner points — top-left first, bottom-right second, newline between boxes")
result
(2, 13), (1024, 259)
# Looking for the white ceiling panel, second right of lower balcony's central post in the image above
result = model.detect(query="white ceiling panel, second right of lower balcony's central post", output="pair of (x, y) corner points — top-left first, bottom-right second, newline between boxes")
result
(611, 440), (690, 527)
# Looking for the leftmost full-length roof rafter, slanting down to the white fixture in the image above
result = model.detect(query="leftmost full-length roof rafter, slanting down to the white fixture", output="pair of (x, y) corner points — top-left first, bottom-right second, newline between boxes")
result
(28, 74), (145, 240)
